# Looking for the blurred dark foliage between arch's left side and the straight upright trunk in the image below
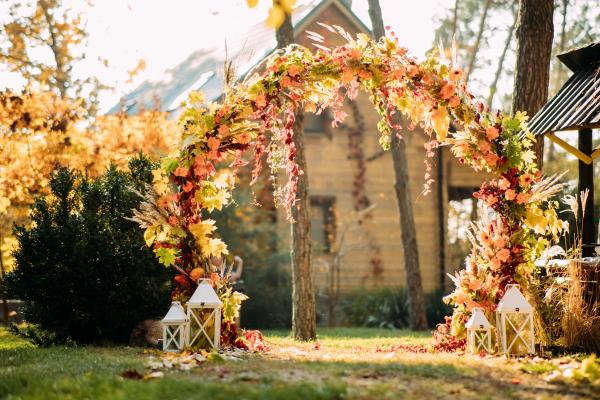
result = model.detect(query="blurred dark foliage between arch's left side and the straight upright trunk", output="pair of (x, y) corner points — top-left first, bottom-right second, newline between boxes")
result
(211, 172), (292, 329)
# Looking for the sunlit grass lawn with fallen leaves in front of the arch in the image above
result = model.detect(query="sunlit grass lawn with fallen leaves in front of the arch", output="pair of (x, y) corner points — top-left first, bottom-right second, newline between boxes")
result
(0, 328), (597, 400)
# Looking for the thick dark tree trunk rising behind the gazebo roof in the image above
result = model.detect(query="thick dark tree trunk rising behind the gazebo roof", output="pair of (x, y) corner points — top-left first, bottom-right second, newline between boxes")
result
(512, 0), (554, 170)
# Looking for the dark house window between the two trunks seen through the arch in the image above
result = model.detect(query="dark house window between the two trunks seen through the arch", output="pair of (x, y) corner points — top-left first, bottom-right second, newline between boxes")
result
(310, 196), (335, 253)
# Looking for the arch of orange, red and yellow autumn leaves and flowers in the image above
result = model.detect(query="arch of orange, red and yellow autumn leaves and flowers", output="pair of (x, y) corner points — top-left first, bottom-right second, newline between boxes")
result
(136, 27), (564, 335)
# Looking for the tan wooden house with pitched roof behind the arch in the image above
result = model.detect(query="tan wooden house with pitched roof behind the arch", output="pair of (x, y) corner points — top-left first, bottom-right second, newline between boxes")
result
(112, 0), (482, 292)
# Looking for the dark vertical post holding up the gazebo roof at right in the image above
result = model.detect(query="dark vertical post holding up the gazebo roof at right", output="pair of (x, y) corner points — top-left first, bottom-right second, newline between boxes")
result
(578, 129), (596, 257)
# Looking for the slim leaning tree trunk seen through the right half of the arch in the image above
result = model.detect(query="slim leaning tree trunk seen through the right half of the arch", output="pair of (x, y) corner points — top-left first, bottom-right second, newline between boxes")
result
(369, 0), (427, 330)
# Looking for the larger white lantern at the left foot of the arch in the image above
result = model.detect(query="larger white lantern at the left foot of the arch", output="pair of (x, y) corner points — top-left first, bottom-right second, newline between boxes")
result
(187, 279), (223, 349)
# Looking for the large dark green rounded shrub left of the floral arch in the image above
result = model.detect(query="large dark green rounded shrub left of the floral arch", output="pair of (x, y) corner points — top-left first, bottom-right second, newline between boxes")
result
(7, 154), (172, 343)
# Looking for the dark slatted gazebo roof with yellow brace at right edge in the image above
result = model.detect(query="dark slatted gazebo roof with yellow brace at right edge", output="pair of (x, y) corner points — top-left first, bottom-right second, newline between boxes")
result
(529, 42), (600, 164)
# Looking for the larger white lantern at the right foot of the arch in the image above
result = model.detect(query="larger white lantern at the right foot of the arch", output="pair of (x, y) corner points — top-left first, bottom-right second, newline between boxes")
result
(496, 284), (535, 355)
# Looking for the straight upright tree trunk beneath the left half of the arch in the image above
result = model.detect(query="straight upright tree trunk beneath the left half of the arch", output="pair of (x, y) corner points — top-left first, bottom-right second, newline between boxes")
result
(274, 1), (317, 340)
